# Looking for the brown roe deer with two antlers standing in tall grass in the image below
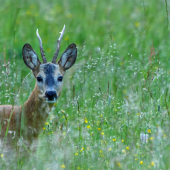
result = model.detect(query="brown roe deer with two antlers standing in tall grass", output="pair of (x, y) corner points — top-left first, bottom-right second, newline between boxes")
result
(0, 25), (77, 148)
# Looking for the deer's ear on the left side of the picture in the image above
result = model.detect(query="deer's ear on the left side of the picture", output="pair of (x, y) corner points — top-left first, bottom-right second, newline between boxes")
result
(22, 44), (41, 71)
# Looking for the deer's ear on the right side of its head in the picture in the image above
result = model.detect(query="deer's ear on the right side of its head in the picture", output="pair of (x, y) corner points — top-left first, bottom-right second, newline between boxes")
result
(58, 43), (77, 70)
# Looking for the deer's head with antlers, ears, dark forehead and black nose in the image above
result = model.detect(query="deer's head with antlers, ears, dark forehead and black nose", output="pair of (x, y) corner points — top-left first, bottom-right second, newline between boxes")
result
(22, 26), (77, 103)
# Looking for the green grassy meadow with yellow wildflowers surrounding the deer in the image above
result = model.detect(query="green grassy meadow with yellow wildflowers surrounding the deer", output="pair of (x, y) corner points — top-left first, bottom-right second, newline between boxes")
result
(0, 0), (170, 170)
